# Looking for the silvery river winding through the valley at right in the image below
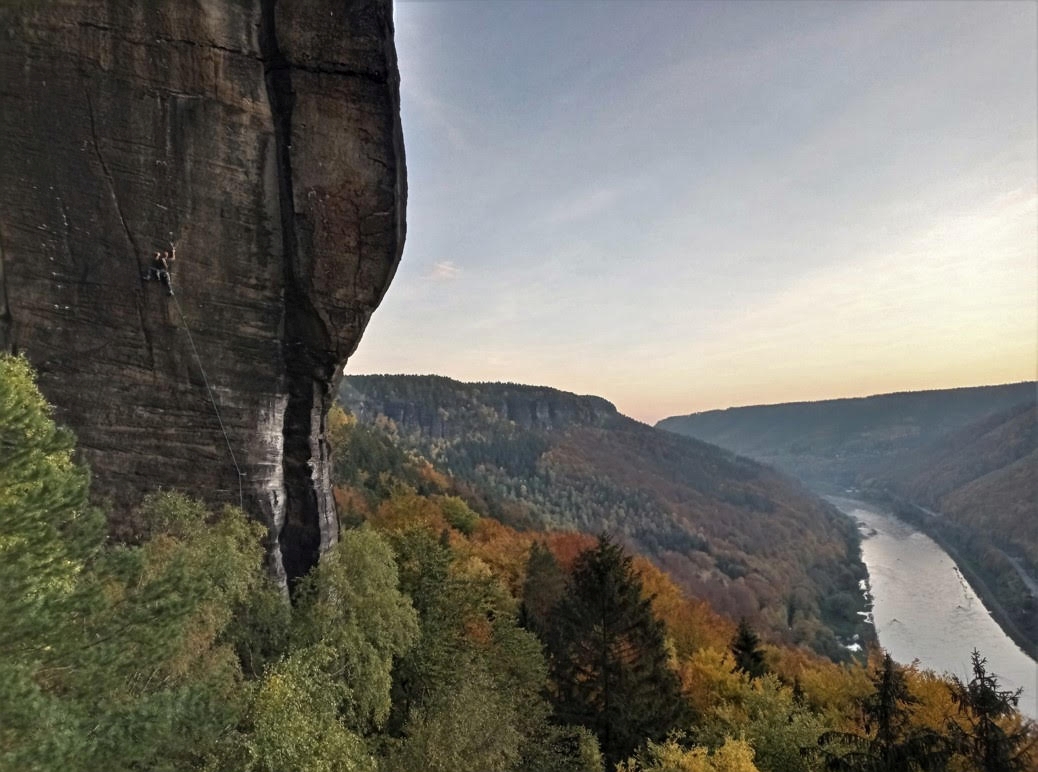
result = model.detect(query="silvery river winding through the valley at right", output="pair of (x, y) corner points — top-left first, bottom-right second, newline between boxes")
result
(827, 496), (1038, 718)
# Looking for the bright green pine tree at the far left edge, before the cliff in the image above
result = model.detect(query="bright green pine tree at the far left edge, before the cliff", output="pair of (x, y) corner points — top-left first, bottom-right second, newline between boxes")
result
(0, 355), (103, 770)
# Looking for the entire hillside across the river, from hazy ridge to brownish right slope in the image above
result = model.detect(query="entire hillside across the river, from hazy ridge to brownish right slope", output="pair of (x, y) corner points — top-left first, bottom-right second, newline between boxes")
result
(658, 383), (1038, 652)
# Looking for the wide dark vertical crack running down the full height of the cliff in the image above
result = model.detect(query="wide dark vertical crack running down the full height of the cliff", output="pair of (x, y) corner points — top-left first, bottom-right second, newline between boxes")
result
(260, 0), (335, 591)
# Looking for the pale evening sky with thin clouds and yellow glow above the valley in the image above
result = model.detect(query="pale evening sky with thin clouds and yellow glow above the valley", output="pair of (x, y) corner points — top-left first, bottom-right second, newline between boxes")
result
(347, 0), (1038, 422)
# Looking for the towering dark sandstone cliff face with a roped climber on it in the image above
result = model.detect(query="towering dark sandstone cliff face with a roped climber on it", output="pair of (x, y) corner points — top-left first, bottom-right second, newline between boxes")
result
(0, 0), (406, 580)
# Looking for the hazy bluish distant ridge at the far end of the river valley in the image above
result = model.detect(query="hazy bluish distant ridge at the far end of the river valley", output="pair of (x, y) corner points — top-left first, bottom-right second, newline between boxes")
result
(656, 382), (1036, 487)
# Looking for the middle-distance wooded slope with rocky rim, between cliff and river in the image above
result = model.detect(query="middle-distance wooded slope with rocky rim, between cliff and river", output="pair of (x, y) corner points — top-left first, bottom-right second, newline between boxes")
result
(340, 376), (868, 658)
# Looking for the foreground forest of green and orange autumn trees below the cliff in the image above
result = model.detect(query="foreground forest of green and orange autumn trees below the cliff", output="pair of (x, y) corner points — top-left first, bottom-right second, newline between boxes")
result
(0, 357), (1038, 772)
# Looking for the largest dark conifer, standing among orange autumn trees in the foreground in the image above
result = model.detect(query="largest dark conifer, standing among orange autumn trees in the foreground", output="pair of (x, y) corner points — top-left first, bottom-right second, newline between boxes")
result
(548, 536), (687, 769)
